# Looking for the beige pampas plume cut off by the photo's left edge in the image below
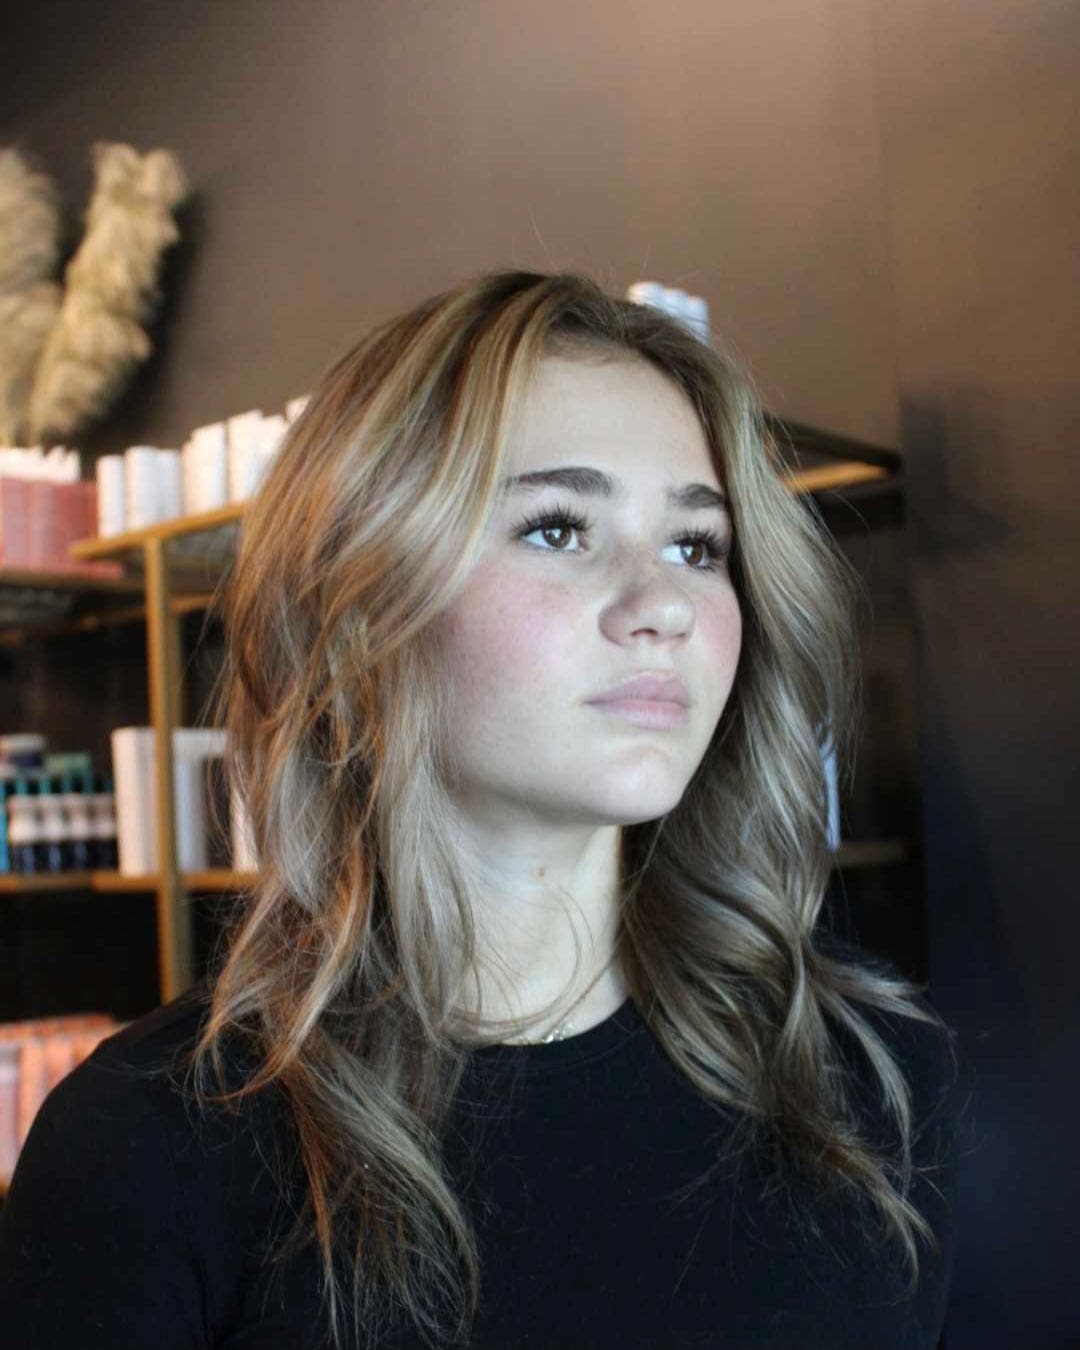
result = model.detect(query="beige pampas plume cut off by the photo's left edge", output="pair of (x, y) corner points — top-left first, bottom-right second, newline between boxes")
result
(0, 150), (61, 446)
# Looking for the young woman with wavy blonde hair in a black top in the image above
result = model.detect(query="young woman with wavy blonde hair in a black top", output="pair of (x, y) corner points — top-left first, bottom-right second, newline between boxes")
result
(0, 271), (957, 1350)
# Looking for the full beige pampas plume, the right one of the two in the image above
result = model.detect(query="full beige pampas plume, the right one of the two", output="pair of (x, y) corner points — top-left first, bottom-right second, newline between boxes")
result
(26, 142), (186, 441)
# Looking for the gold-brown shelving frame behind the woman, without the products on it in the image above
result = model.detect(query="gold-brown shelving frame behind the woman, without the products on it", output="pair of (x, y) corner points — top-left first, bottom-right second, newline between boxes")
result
(0, 414), (910, 1002)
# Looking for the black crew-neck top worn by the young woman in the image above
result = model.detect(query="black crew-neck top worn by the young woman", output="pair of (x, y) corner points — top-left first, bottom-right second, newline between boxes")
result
(0, 984), (960, 1350)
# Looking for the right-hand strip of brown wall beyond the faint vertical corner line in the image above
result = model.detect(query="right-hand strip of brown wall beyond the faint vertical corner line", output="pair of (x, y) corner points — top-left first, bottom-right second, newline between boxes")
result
(876, 0), (1080, 1350)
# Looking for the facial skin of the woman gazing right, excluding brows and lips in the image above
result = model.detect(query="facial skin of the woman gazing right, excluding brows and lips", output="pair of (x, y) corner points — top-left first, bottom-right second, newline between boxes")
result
(440, 358), (743, 829)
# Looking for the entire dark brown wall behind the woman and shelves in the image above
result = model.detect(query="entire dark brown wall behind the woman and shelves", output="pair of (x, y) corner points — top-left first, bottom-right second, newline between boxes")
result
(0, 0), (1080, 1350)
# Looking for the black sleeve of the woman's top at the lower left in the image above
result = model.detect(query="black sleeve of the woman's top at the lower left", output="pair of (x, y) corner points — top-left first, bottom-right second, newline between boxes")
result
(0, 1060), (208, 1350)
